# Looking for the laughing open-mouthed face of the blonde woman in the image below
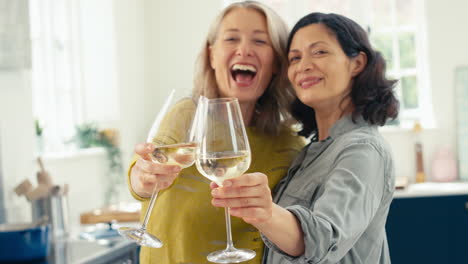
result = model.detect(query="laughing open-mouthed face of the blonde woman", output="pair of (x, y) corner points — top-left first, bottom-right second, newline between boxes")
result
(210, 8), (275, 103)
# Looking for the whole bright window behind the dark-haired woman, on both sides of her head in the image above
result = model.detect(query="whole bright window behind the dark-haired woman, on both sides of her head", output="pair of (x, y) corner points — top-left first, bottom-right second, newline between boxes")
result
(224, 0), (433, 128)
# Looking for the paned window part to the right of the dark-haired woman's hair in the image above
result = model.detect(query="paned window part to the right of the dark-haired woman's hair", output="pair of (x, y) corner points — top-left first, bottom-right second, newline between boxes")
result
(370, 0), (433, 127)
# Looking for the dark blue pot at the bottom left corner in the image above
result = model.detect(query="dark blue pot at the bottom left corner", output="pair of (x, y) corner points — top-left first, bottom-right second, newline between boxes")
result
(0, 224), (49, 263)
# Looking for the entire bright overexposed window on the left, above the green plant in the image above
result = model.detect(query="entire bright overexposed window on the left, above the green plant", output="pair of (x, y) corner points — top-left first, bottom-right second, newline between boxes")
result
(30, 0), (119, 152)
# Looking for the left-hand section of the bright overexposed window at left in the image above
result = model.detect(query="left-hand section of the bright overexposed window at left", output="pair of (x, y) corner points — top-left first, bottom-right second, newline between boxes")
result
(29, 0), (82, 151)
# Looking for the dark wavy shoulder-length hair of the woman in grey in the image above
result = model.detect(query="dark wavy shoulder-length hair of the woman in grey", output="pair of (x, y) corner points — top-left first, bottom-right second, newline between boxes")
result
(287, 13), (399, 138)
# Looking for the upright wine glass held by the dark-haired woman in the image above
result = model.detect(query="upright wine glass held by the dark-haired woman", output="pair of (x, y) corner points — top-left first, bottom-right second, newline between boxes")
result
(195, 98), (255, 263)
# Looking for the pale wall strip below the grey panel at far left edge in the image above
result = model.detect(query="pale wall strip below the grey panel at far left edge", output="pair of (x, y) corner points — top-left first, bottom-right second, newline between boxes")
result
(0, 69), (35, 219)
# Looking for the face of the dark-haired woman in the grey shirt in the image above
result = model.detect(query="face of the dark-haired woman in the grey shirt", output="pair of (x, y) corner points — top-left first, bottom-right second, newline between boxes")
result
(288, 24), (366, 111)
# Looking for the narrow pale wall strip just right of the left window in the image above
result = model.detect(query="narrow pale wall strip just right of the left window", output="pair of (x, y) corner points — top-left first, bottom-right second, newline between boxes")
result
(114, 0), (149, 164)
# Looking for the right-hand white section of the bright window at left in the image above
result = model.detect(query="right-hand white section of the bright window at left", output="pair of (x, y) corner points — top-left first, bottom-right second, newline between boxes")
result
(78, 0), (120, 123)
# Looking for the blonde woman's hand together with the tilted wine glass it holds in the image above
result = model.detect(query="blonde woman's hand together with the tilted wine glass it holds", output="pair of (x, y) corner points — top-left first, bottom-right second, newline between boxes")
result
(118, 90), (196, 248)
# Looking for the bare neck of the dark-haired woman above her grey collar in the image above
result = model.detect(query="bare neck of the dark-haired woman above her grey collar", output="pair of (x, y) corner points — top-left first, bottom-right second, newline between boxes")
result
(315, 99), (353, 141)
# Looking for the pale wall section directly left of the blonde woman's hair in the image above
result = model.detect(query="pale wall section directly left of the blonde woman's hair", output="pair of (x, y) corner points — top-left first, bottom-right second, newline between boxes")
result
(147, 0), (222, 98)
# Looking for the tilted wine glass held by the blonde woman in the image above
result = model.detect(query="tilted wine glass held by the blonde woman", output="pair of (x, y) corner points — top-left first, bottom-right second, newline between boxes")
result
(118, 90), (201, 248)
